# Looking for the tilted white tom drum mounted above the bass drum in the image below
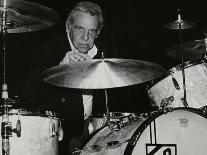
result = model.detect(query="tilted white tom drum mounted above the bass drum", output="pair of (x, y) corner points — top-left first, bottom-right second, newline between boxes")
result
(147, 60), (207, 108)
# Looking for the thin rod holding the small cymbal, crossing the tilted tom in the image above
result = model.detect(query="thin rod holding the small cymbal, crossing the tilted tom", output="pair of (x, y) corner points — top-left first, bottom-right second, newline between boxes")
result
(178, 9), (188, 107)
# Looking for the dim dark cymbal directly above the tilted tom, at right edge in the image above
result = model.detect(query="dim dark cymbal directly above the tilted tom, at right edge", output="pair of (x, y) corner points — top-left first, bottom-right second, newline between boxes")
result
(165, 40), (205, 60)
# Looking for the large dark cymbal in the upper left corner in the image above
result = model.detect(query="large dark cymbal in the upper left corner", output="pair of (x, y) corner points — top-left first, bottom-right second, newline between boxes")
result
(0, 0), (58, 33)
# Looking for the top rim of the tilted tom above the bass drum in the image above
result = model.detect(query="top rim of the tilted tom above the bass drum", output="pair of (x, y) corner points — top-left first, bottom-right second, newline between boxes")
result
(146, 59), (207, 92)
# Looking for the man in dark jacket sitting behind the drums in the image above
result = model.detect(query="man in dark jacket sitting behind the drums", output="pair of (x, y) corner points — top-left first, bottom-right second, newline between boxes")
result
(25, 1), (104, 154)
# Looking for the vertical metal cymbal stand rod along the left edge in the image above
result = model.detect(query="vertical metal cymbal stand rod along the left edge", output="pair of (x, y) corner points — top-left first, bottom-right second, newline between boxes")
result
(1, 0), (11, 155)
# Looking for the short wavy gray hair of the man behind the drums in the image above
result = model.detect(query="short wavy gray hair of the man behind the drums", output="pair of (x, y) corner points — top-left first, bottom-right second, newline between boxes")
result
(67, 1), (104, 31)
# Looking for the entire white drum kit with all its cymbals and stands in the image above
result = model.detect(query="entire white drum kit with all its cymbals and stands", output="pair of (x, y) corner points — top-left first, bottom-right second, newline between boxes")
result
(0, 0), (207, 155)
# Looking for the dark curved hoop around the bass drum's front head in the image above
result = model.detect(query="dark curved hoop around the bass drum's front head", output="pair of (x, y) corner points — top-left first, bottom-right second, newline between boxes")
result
(124, 107), (207, 155)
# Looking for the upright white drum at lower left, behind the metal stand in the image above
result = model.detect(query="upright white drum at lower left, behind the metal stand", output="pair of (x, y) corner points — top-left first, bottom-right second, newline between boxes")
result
(0, 109), (61, 155)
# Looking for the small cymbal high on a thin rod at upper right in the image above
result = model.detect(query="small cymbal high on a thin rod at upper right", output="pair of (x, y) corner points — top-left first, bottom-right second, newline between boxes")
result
(164, 20), (196, 30)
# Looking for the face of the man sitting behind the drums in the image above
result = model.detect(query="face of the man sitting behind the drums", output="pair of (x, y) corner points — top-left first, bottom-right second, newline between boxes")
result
(67, 13), (99, 53)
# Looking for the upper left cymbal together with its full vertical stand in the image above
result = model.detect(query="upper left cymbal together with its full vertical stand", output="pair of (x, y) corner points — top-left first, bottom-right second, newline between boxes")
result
(0, 0), (58, 155)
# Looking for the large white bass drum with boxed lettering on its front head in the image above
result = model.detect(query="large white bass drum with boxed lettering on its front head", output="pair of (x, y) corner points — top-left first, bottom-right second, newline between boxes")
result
(81, 108), (207, 155)
